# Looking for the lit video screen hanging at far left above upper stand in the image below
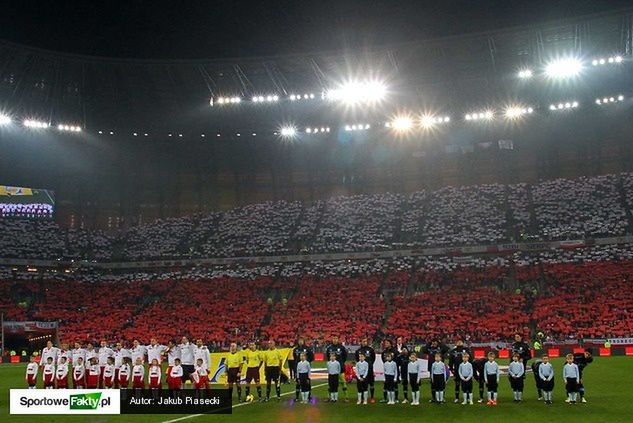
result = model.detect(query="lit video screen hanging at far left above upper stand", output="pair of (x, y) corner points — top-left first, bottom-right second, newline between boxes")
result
(0, 185), (55, 219)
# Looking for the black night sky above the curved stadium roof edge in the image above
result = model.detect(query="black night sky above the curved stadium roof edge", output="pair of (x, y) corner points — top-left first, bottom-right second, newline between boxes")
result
(0, 0), (631, 59)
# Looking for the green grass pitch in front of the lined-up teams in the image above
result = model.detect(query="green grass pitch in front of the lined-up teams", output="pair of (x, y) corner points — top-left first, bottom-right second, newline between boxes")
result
(0, 357), (633, 423)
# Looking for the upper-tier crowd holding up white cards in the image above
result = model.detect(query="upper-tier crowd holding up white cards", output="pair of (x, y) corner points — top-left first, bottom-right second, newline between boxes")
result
(0, 173), (633, 260)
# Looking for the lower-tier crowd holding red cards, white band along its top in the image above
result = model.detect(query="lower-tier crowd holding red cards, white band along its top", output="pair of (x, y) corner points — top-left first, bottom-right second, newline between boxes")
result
(0, 244), (633, 345)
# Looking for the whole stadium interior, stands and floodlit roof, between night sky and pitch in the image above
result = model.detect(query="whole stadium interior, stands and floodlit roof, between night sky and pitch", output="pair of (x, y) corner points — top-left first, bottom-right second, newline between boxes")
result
(0, 5), (633, 349)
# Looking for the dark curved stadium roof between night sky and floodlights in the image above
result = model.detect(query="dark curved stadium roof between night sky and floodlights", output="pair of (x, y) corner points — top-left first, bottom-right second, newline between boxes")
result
(0, 8), (633, 129)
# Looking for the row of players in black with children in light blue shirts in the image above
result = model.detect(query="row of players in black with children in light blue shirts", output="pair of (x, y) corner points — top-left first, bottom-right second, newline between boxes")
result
(314, 334), (593, 405)
